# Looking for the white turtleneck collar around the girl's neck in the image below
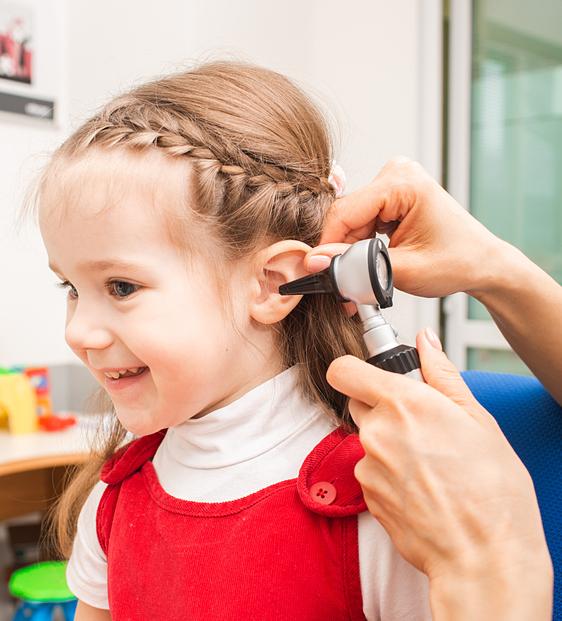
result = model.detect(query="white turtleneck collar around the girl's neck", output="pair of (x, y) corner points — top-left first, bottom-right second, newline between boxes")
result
(163, 365), (323, 469)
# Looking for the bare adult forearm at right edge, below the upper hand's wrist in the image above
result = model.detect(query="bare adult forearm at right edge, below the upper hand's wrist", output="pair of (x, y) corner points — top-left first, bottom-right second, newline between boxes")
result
(467, 242), (562, 404)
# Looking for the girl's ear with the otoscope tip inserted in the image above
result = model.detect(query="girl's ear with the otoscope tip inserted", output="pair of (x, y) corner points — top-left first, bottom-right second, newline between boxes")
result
(249, 239), (311, 324)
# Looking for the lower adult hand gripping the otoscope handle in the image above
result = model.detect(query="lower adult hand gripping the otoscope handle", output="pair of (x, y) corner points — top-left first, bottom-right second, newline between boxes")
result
(326, 332), (552, 619)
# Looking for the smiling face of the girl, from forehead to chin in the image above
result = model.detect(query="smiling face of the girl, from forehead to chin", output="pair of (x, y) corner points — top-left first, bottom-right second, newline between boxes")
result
(39, 151), (278, 435)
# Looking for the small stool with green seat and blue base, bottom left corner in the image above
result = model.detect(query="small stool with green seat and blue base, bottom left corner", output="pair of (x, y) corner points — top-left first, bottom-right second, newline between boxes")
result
(8, 561), (78, 621)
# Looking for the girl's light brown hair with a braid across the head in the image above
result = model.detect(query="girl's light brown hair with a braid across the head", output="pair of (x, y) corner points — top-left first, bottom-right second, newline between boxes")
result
(31, 61), (366, 557)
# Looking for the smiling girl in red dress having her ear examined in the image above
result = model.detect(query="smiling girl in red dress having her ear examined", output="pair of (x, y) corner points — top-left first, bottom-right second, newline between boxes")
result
(31, 62), (431, 621)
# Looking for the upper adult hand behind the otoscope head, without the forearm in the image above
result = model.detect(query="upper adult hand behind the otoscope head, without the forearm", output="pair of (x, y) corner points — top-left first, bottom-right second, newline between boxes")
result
(305, 157), (507, 308)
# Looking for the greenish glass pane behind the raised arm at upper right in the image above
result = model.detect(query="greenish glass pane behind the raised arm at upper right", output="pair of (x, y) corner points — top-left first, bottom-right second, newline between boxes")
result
(468, 0), (562, 319)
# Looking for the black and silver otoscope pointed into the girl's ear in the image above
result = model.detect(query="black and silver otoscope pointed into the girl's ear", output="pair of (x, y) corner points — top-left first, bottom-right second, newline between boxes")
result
(279, 237), (423, 382)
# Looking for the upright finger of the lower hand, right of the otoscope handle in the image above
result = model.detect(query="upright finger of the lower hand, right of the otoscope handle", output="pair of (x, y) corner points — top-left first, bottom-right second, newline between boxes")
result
(416, 328), (482, 415)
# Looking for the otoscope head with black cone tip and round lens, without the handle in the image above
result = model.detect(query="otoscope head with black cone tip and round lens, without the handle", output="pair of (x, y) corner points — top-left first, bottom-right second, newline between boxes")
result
(279, 238), (394, 308)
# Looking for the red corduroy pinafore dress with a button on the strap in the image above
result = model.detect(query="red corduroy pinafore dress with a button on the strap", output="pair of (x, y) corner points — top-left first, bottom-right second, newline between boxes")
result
(97, 428), (366, 621)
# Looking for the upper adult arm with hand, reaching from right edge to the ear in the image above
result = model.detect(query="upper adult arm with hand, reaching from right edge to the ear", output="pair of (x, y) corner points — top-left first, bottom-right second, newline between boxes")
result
(305, 158), (562, 404)
